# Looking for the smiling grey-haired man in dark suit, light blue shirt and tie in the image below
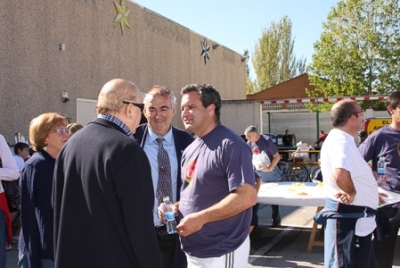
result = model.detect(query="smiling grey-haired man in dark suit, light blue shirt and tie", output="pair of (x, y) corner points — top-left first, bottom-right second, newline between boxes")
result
(135, 85), (193, 268)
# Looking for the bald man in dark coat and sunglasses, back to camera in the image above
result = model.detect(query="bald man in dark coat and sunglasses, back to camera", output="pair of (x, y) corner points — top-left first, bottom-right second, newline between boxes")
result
(53, 79), (162, 268)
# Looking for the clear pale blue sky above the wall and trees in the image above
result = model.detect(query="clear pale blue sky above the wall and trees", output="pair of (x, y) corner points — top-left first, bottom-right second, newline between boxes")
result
(133, 0), (339, 78)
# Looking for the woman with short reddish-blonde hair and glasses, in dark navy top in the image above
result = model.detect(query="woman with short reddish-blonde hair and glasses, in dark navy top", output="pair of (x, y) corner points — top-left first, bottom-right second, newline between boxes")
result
(18, 113), (69, 268)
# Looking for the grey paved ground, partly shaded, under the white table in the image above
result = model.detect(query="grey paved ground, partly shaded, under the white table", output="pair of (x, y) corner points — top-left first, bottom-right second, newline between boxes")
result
(6, 205), (400, 268)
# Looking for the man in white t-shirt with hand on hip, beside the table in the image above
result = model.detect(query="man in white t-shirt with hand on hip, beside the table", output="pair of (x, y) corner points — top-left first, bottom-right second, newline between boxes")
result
(314, 100), (379, 268)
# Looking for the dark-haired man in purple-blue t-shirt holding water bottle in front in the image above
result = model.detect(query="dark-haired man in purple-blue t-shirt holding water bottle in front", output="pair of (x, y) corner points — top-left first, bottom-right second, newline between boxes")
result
(177, 84), (257, 268)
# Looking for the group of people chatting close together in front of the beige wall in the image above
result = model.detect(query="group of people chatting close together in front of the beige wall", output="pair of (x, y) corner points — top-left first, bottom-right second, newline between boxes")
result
(0, 79), (256, 267)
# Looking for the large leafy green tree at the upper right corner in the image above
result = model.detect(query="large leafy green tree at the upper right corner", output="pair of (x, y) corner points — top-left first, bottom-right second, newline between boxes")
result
(307, 0), (400, 110)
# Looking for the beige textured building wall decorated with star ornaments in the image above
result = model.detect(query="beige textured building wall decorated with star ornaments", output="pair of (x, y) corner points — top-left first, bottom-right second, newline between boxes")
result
(0, 0), (246, 144)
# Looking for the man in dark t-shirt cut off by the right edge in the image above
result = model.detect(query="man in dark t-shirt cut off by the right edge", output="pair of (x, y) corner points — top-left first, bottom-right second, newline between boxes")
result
(359, 91), (400, 268)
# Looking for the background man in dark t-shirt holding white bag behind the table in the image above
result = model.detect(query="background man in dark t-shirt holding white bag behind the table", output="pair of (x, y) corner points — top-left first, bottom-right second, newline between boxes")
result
(244, 126), (281, 227)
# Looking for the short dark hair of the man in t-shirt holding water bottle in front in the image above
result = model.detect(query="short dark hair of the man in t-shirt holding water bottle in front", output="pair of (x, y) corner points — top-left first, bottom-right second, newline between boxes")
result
(181, 84), (221, 122)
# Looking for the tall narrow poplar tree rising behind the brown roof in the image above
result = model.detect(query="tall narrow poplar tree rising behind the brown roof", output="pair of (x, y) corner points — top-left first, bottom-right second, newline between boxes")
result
(252, 16), (306, 90)
